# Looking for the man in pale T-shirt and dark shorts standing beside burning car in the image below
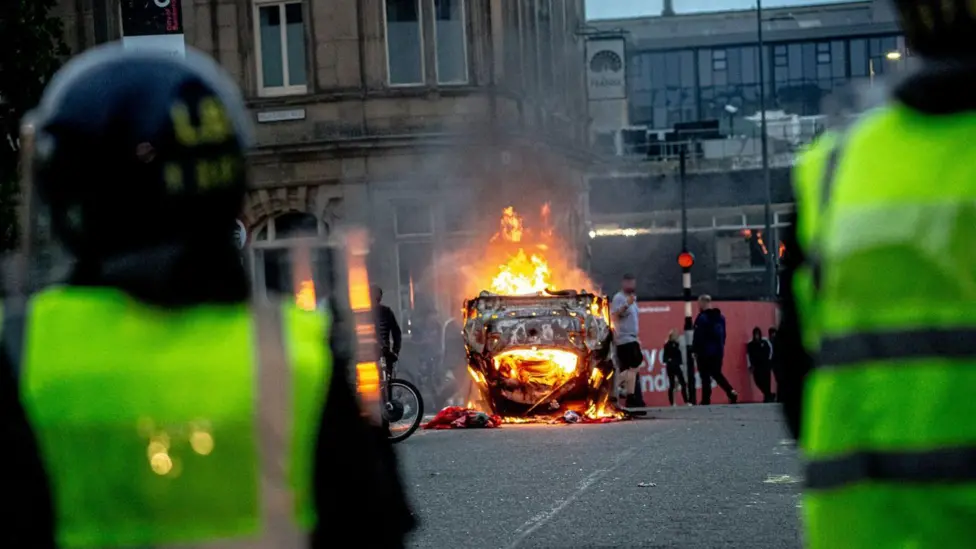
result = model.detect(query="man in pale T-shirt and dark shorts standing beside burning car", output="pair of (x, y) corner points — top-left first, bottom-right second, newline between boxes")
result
(610, 274), (644, 408)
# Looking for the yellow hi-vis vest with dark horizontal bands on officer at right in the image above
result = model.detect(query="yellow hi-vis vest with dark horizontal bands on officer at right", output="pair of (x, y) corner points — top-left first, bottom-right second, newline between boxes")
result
(787, 105), (976, 549)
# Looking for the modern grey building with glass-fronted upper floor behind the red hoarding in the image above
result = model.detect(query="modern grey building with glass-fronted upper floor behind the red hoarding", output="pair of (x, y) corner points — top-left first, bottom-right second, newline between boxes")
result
(587, 0), (912, 299)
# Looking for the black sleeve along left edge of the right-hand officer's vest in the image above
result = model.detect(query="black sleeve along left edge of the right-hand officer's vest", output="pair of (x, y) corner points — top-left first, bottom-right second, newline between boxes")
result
(775, 220), (813, 438)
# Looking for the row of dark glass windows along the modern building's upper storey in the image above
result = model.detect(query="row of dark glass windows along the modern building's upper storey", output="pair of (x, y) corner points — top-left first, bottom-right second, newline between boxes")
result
(628, 34), (910, 130)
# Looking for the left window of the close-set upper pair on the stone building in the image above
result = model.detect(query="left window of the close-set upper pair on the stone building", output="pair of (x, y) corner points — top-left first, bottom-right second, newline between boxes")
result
(383, 0), (424, 86)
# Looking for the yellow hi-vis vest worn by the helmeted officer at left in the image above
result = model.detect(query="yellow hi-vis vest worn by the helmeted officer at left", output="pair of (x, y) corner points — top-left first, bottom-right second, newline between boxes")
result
(0, 287), (332, 549)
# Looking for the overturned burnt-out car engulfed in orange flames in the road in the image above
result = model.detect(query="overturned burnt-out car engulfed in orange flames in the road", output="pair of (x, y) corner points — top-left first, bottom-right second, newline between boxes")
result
(462, 204), (622, 421)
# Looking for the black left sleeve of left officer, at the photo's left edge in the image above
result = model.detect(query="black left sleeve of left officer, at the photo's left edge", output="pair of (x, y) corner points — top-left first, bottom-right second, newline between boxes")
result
(0, 332), (55, 549)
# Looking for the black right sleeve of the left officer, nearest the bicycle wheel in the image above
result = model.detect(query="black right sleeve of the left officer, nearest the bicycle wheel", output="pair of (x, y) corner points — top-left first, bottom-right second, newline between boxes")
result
(312, 346), (416, 549)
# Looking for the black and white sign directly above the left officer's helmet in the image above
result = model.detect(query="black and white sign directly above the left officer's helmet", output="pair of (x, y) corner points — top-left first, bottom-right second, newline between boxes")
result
(119, 0), (186, 55)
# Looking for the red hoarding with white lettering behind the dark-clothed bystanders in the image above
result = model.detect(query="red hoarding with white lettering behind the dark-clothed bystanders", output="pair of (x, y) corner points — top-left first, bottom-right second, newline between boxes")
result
(640, 301), (776, 406)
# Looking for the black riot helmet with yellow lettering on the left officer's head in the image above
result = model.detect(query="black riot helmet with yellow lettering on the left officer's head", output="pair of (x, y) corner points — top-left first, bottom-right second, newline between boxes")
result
(26, 45), (251, 258)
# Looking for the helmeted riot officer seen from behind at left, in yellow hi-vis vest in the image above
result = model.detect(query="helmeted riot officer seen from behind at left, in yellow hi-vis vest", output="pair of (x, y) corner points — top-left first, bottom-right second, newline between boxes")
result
(0, 46), (413, 548)
